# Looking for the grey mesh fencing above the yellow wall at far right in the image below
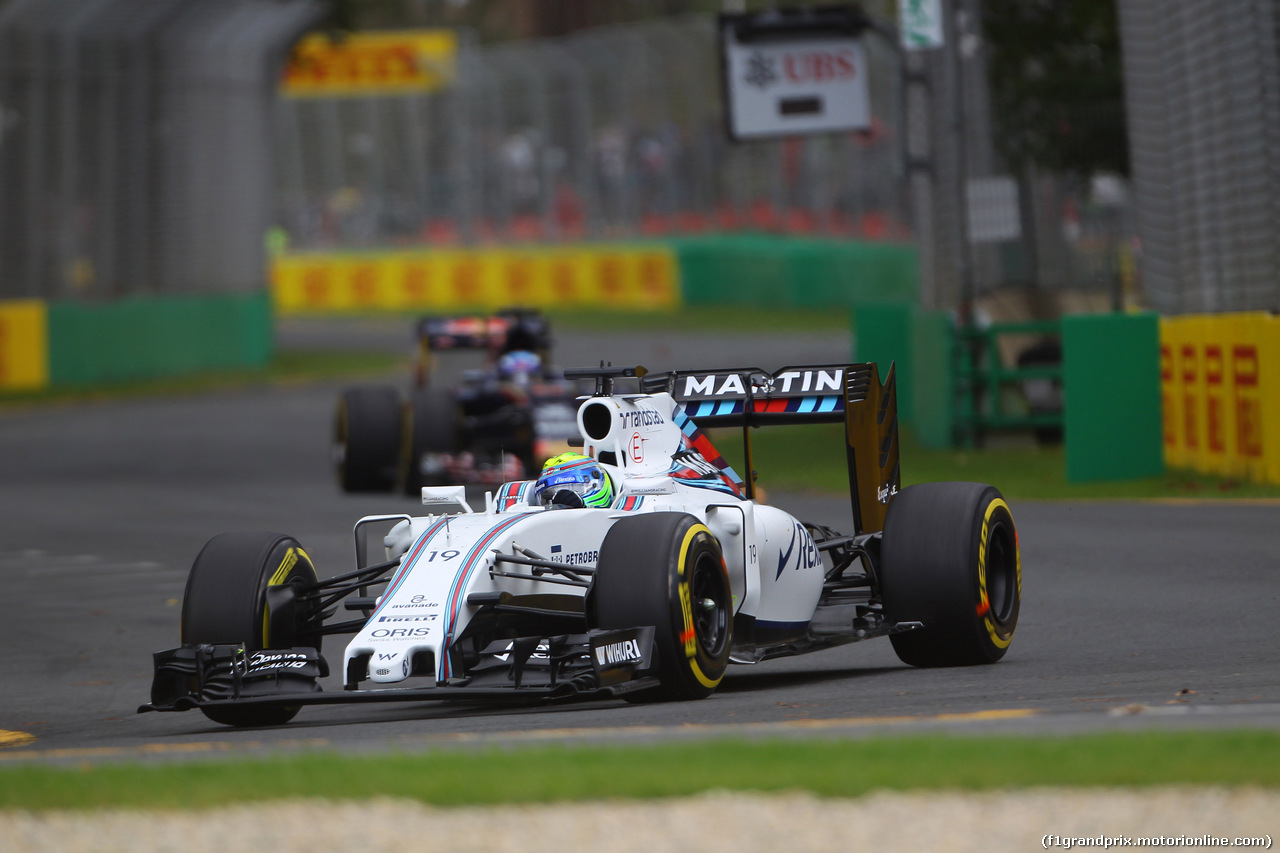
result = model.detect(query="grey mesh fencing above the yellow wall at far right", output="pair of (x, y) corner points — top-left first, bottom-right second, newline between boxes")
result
(1119, 0), (1280, 314)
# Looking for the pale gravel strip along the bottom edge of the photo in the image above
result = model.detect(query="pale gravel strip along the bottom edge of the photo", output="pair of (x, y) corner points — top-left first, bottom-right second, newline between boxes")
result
(0, 788), (1280, 853)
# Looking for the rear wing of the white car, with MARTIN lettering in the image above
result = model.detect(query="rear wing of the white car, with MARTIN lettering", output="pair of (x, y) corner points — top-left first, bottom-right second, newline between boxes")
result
(640, 361), (901, 533)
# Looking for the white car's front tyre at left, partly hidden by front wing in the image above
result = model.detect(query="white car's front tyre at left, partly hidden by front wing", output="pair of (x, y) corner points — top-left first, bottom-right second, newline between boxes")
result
(182, 533), (321, 726)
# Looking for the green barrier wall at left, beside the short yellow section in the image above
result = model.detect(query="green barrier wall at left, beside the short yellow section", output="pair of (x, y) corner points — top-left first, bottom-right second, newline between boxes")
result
(49, 292), (273, 386)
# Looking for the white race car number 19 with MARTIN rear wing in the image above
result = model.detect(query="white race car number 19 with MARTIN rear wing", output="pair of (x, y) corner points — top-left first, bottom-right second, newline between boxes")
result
(140, 364), (1021, 725)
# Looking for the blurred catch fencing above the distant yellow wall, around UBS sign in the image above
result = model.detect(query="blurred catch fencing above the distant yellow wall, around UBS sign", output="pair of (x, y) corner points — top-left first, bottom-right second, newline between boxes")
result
(276, 17), (908, 250)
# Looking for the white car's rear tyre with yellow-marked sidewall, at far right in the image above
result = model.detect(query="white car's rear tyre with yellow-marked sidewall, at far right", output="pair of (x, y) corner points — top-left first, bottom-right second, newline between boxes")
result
(879, 483), (1021, 666)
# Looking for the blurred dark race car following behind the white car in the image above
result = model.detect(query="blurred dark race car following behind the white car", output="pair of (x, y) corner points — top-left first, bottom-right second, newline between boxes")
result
(333, 309), (579, 496)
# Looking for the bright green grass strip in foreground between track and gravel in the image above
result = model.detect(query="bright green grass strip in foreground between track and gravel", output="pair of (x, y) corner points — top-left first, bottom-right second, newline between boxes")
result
(0, 730), (1280, 809)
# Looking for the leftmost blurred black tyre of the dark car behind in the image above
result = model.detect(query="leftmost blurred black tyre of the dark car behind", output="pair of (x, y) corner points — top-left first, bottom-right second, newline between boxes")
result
(333, 386), (402, 492)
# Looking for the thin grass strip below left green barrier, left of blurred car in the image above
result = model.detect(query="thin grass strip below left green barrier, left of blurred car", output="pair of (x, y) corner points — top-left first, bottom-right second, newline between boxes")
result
(0, 351), (410, 407)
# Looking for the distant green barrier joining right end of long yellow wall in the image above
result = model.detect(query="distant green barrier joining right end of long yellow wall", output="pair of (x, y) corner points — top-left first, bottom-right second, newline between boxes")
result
(669, 234), (919, 307)
